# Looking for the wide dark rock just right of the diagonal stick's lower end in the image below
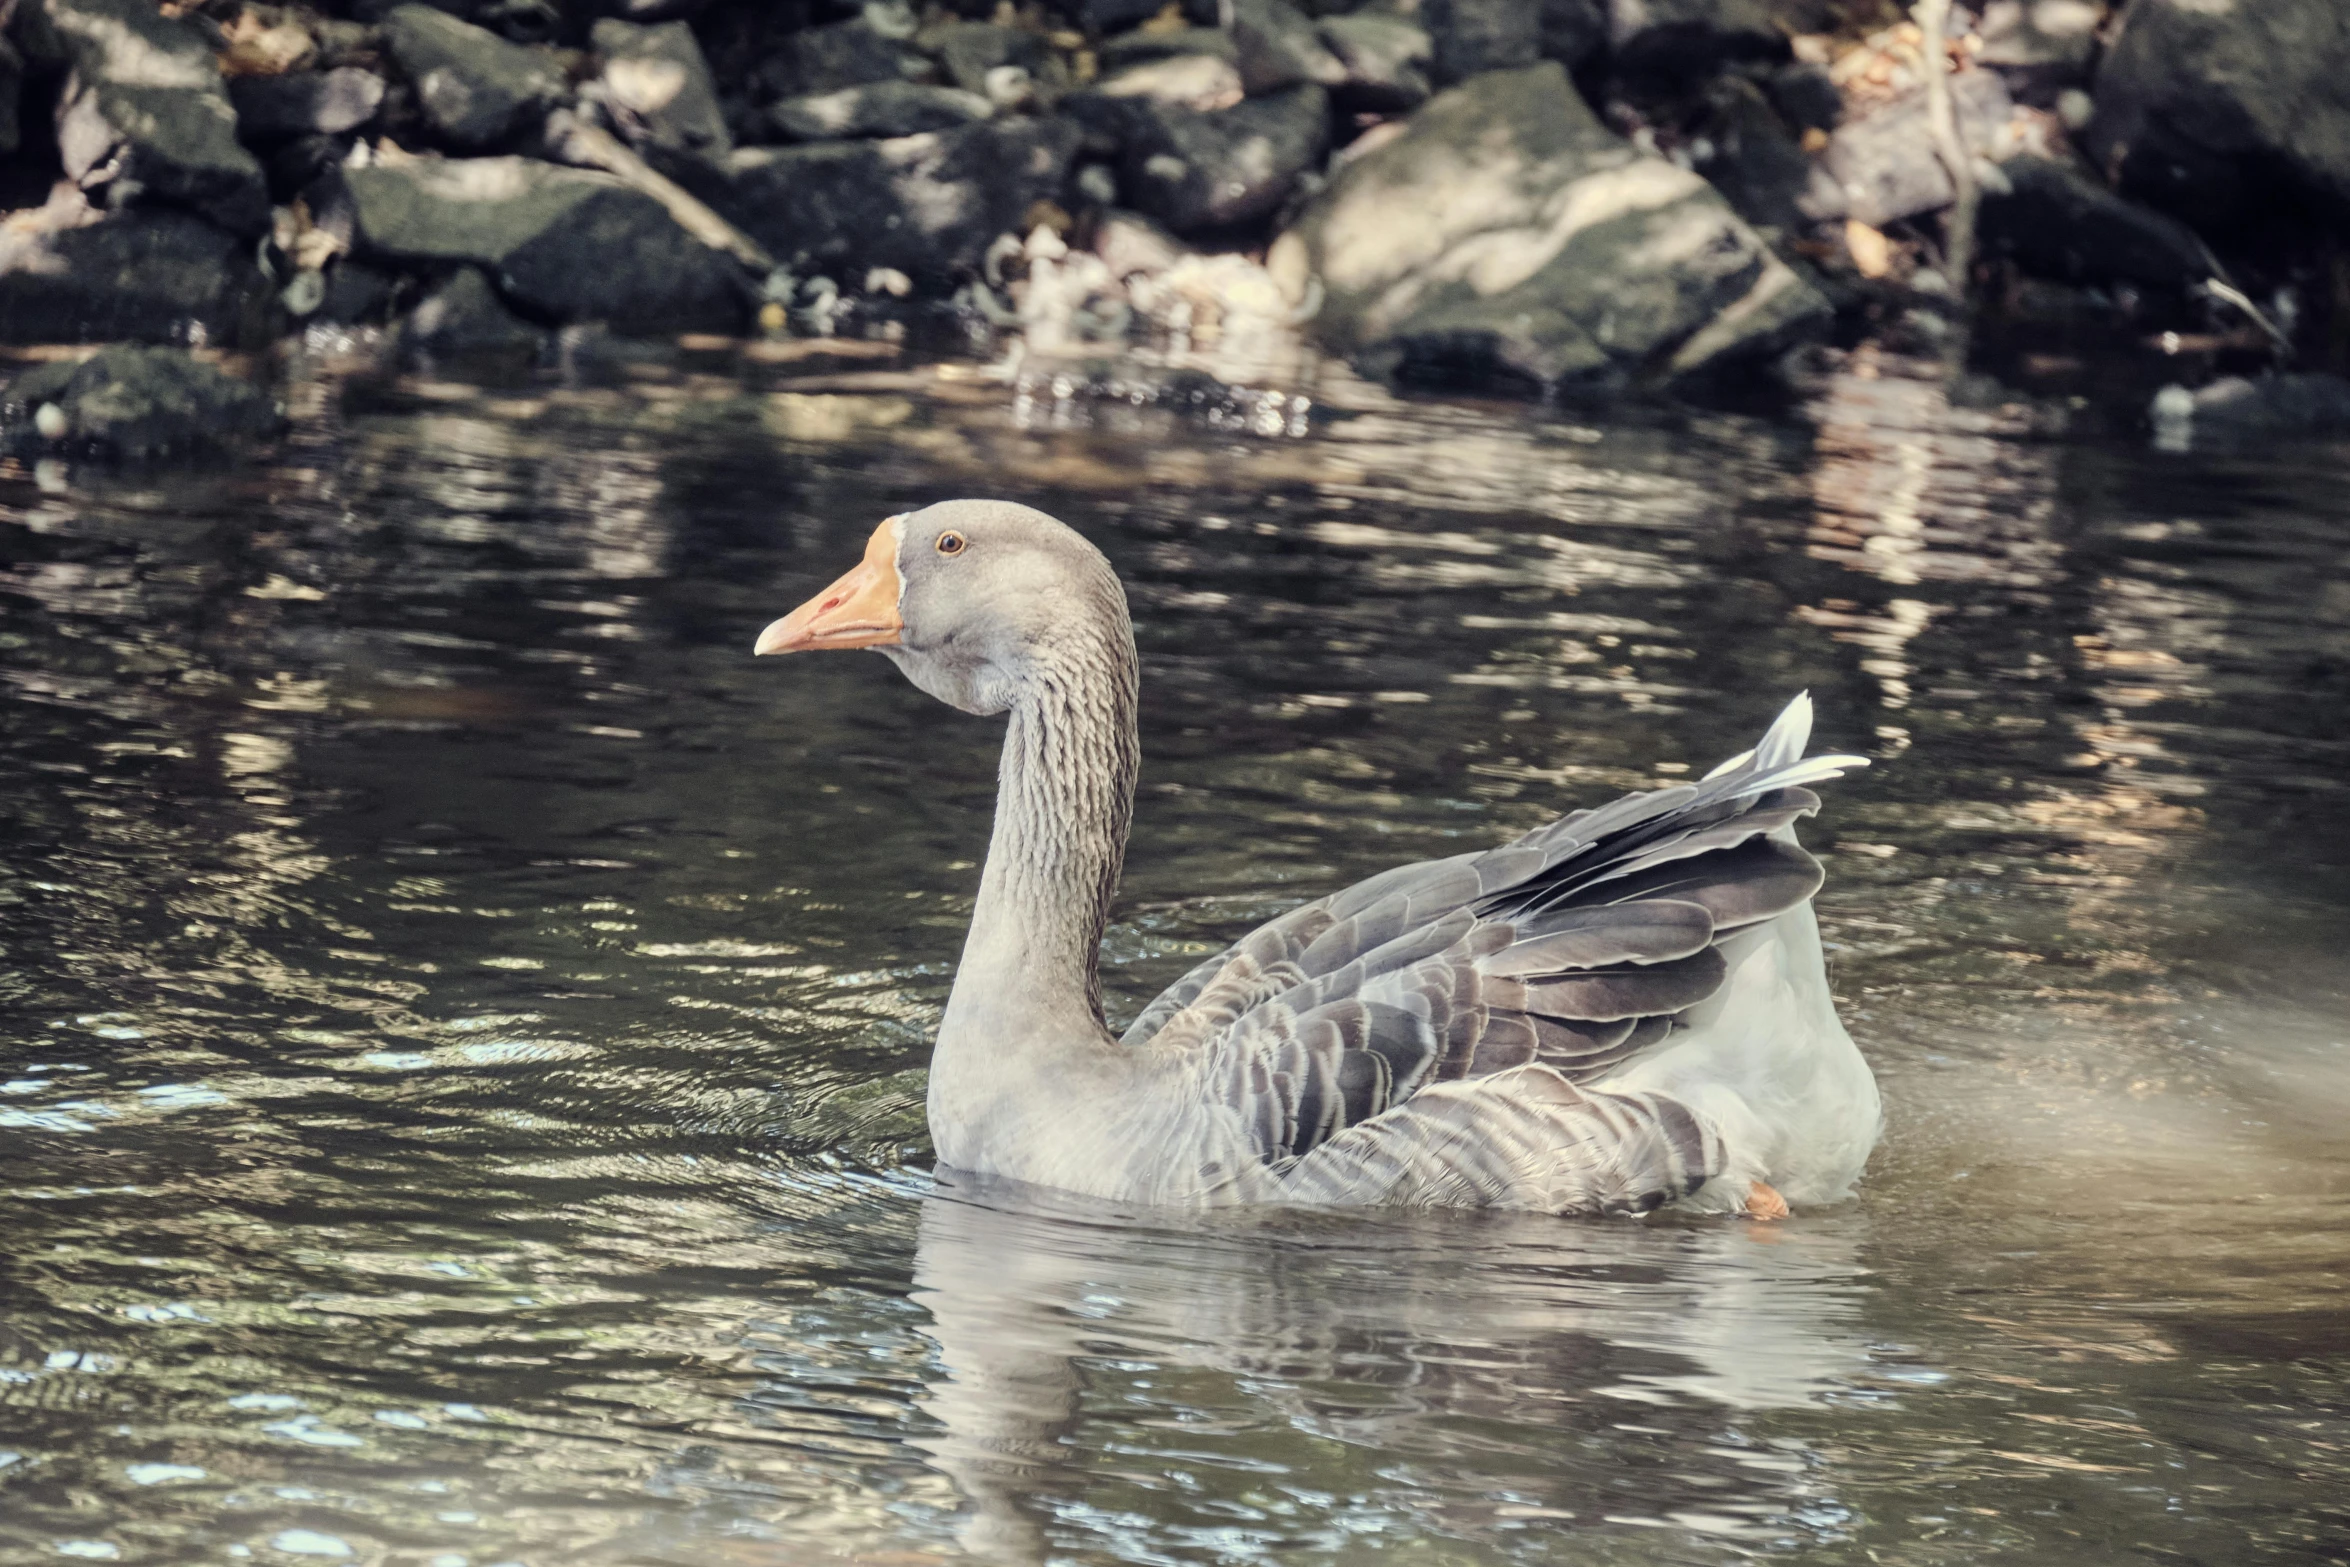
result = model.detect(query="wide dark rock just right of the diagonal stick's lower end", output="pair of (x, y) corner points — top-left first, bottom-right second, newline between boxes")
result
(726, 120), (1081, 291)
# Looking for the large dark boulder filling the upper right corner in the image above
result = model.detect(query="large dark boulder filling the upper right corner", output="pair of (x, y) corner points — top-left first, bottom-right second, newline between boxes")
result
(2084, 0), (2350, 233)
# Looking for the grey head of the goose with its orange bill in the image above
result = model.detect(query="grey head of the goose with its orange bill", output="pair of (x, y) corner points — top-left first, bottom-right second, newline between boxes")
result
(752, 500), (1133, 714)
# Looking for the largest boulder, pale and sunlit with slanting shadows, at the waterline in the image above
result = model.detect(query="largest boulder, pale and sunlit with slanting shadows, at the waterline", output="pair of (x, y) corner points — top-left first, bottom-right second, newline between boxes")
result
(1267, 61), (1831, 390)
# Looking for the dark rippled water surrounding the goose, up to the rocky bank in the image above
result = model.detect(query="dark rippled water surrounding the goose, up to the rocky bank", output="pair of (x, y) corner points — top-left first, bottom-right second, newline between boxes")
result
(0, 350), (2350, 1567)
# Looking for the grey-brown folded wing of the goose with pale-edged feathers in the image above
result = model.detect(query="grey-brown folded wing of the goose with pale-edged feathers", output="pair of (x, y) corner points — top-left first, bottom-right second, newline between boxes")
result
(1126, 698), (1866, 1210)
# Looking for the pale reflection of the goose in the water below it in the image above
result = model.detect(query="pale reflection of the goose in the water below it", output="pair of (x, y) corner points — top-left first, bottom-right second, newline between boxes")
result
(914, 1177), (1871, 1562)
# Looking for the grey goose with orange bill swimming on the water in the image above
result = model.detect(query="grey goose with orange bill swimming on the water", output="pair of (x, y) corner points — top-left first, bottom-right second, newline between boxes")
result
(754, 500), (1882, 1219)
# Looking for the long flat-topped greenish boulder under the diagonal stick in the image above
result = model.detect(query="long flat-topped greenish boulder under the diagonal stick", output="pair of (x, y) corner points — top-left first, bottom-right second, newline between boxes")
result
(343, 157), (747, 331)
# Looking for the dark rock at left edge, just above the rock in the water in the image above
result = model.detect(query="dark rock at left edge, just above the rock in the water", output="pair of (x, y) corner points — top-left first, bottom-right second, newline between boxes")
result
(0, 204), (273, 348)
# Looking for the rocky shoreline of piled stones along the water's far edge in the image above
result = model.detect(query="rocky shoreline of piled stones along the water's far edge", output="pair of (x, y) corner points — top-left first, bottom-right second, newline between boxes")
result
(0, 0), (2350, 453)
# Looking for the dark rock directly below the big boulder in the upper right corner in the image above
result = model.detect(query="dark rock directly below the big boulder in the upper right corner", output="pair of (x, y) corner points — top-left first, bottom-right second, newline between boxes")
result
(1976, 157), (2218, 291)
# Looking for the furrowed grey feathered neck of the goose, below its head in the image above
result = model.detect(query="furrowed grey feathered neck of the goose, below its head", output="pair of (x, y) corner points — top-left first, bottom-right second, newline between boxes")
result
(956, 601), (1140, 1038)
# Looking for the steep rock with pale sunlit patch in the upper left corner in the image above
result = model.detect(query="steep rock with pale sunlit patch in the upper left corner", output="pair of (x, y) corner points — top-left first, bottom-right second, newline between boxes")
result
(34, 0), (270, 235)
